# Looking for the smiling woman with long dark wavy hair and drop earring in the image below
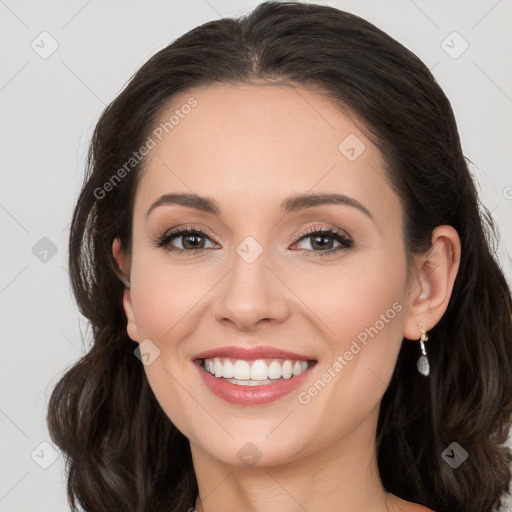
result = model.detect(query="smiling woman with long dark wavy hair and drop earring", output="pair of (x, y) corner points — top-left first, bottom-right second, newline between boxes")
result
(48, 2), (512, 512)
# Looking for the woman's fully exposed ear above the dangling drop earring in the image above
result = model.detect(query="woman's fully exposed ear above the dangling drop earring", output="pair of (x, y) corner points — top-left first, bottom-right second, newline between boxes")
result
(403, 225), (460, 340)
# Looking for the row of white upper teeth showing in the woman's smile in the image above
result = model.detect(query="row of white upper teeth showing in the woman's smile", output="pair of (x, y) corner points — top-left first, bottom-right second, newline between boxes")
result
(203, 357), (309, 386)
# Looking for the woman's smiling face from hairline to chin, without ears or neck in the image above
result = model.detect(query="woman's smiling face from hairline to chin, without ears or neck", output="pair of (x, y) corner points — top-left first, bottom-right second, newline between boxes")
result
(117, 85), (416, 466)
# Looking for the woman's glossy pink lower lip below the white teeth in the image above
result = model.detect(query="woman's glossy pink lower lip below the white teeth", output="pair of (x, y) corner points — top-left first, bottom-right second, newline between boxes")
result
(194, 361), (314, 405)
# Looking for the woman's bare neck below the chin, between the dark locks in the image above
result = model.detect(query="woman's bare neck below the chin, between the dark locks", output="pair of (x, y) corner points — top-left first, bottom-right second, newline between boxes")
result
(191, 404), (402, 512)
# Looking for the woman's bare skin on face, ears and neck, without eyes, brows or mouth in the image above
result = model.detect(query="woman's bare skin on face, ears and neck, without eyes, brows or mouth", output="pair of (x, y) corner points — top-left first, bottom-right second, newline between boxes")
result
(113, 85), (460, 512)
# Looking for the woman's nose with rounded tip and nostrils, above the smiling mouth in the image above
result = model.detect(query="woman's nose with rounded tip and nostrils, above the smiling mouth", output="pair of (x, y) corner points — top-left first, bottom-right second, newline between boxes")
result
(214, 244), (290, 331)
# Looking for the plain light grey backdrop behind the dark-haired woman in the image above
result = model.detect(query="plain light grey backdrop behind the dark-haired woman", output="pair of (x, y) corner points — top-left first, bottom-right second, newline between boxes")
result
(0, 0), (512, 512)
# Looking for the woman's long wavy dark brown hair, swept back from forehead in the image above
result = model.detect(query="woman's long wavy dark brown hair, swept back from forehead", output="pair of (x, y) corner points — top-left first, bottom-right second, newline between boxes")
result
(47, 2), (512, 512)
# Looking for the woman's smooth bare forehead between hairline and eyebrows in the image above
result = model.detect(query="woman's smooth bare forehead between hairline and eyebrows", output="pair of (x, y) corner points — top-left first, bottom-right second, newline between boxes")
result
(135, 85), (397, 223)
